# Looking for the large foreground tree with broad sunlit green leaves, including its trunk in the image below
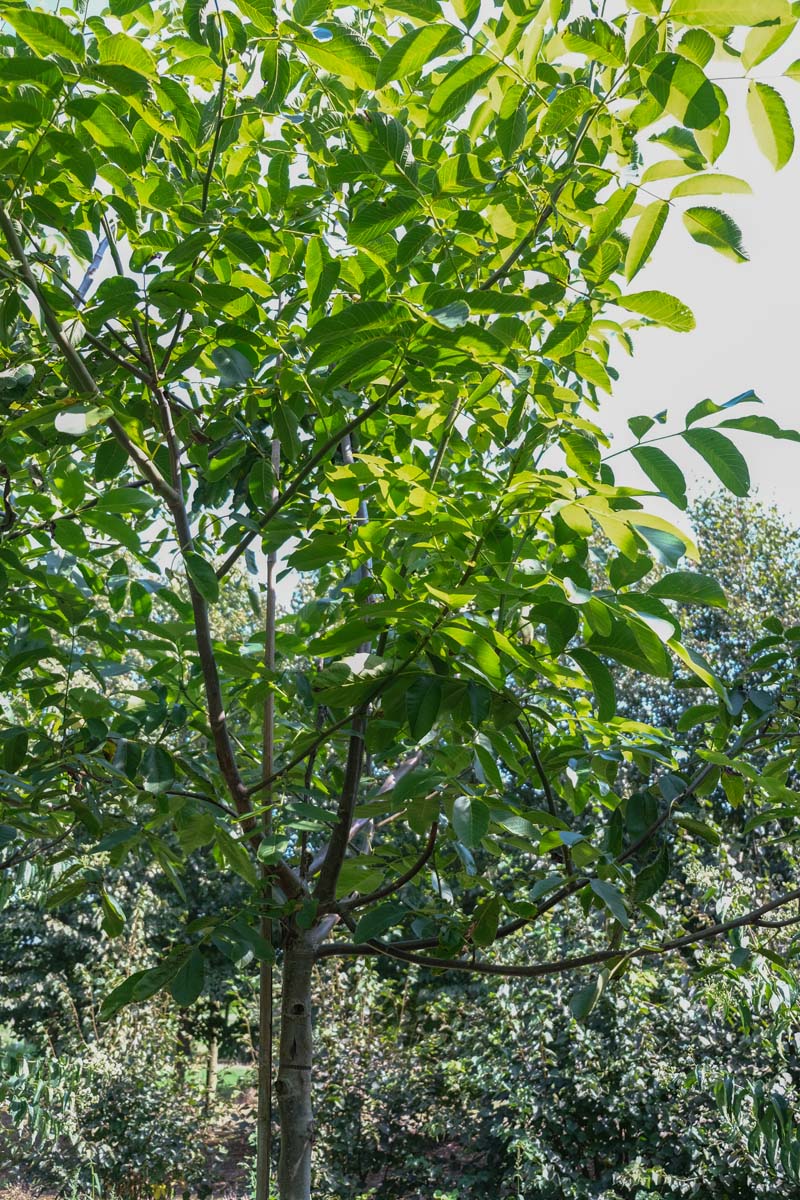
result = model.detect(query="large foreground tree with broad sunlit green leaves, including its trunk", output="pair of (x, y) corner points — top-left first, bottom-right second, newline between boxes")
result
(0, 0), (800, 1200)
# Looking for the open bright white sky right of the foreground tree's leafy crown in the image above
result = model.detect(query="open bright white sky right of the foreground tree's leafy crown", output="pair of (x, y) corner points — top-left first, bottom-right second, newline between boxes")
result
(600, 64), (800, 523)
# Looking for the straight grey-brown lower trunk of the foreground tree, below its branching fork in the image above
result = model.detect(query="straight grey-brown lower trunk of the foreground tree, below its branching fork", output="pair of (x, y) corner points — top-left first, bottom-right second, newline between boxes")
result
(275, 930), (314, 1200)
